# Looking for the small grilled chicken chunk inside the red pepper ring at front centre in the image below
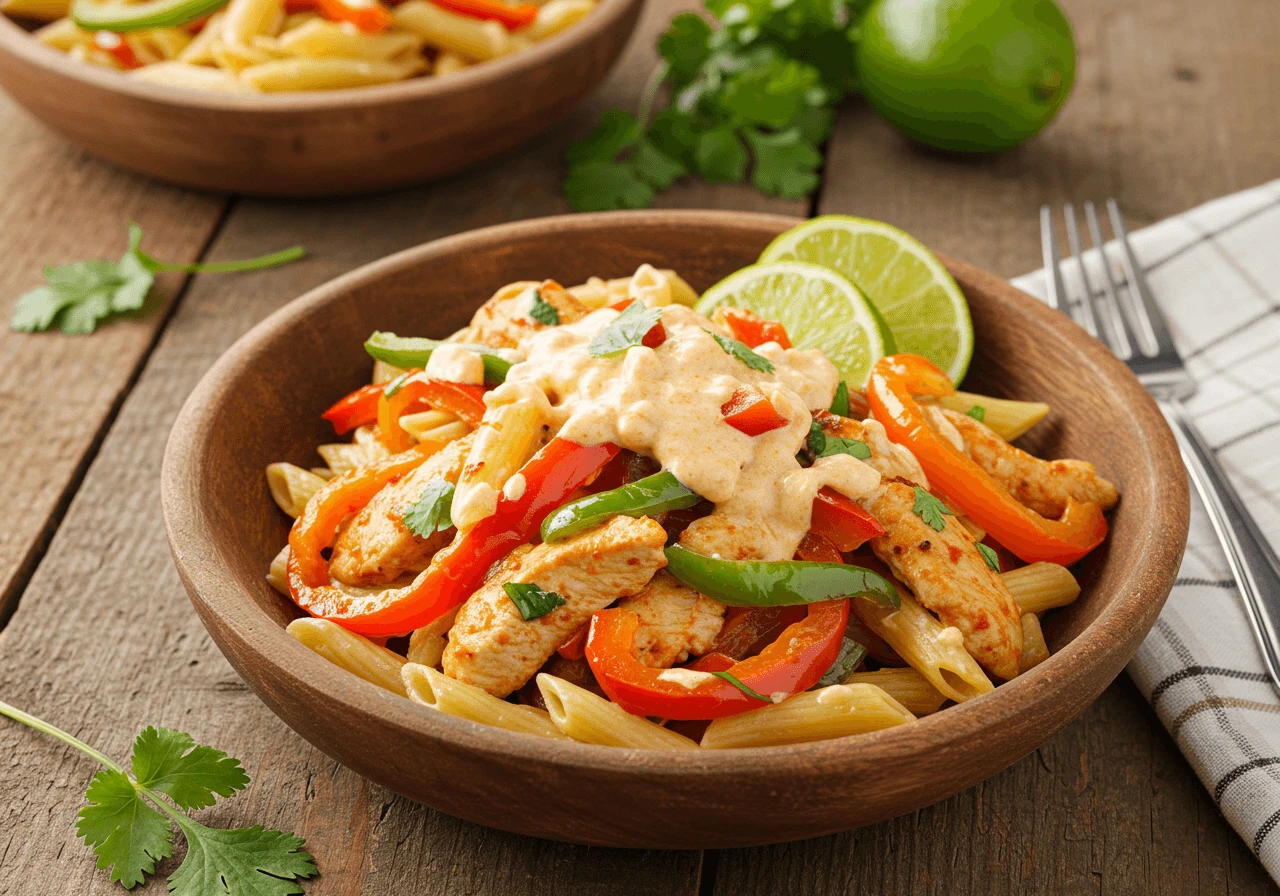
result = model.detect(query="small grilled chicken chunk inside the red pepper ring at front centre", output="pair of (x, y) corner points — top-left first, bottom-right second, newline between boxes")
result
(618, 571), (724, 669)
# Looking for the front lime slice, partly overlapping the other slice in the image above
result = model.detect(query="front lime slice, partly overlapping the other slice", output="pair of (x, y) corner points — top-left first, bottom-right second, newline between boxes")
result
(695, 261), (893, 389)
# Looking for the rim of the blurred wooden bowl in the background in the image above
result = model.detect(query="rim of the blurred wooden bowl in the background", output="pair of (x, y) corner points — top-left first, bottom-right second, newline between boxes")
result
(0, 0), (644, 114)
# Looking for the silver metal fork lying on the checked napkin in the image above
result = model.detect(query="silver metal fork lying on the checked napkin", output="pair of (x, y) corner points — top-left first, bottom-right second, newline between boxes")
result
(1041, 200), (1280, 692)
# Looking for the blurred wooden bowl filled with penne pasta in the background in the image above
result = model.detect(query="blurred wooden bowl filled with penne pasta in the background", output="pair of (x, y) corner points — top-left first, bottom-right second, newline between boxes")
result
(0, 0), (643, 196)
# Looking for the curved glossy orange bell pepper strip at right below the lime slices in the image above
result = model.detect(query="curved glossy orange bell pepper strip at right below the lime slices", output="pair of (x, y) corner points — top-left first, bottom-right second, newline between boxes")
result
(867, 355), (1107, 566)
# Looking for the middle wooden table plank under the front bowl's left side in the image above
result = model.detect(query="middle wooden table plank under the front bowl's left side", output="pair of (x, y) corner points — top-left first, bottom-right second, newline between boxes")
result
(0, 1), (788, 896)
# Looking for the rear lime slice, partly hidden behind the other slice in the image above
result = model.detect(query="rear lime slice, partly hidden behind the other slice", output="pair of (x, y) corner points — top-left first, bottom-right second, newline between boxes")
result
(760, 215), (973, 383)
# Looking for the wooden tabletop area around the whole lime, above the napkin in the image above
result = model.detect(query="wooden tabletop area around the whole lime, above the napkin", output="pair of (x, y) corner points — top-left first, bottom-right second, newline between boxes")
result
(819, 0), (1280, 276)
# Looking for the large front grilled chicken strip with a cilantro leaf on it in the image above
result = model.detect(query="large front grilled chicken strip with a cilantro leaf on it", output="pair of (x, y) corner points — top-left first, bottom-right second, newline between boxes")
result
(444, 516), (665, 696)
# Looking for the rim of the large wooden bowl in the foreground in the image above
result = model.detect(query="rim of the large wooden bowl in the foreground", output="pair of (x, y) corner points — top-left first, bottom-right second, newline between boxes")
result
(161, 210), (1189, 783)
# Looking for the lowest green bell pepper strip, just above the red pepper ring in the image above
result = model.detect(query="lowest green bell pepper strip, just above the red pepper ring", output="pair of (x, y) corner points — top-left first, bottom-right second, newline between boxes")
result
(666, 544), (901, 607)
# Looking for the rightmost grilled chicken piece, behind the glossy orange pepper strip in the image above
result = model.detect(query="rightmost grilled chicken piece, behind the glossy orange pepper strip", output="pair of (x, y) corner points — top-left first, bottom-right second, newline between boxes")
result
(934, 408), (1120, 520)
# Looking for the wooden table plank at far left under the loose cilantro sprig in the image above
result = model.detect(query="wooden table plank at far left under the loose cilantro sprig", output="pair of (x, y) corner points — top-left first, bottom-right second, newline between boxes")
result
(0, 88), (225, 626)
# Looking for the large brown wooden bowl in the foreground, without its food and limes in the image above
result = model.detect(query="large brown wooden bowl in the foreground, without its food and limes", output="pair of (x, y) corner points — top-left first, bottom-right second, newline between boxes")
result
(163, 211), (1188, 849)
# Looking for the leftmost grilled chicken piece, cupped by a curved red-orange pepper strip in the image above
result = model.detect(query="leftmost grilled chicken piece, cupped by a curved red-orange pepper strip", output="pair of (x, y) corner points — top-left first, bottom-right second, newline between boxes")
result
(329, 434), (475, 586)
